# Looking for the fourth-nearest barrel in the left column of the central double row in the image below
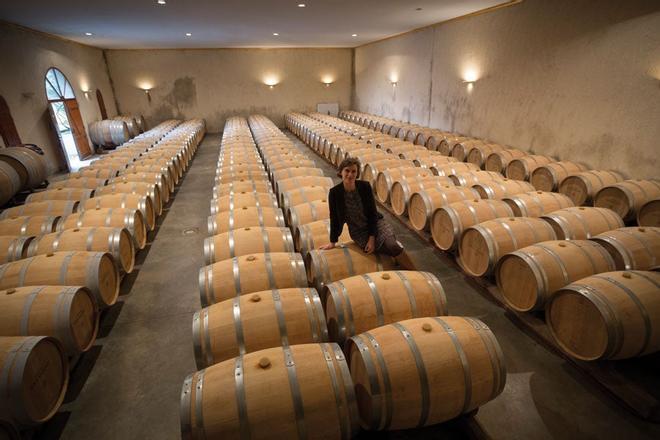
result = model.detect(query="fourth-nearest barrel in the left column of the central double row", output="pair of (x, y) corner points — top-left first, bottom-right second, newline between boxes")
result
(204, 227), (295, 264)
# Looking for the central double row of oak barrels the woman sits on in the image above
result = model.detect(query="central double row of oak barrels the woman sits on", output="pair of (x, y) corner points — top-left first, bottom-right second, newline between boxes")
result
(181, 116), (506, 438)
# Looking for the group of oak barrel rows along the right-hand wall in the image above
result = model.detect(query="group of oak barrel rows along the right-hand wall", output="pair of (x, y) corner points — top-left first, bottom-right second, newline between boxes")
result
(287, 112), (660, 360)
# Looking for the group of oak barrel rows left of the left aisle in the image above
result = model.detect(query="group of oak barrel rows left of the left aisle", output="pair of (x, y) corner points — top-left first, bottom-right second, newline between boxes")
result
(0, 120), (204, 429)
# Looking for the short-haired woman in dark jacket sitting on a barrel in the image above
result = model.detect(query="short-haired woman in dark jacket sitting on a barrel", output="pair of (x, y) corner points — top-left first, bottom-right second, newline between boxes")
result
(319, 157), (415, 270)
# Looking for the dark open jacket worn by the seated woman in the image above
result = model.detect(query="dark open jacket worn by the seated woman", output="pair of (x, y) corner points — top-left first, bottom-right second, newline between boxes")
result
(328, 180), (383, 243)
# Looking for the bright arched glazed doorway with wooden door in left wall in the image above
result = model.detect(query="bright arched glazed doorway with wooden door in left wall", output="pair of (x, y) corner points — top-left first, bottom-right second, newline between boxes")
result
(44, 67), (92, 171)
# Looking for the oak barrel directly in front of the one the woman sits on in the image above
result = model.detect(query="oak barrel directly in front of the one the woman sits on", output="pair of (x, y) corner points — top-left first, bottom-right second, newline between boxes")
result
(322, 270), (447, 345)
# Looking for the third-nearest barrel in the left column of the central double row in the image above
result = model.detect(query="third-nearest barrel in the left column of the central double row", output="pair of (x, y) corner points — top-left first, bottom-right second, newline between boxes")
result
(199, 252), (307, 307)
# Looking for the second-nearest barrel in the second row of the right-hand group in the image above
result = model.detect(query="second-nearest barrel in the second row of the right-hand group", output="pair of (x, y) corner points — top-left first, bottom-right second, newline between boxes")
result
(541, 206), (624, 240)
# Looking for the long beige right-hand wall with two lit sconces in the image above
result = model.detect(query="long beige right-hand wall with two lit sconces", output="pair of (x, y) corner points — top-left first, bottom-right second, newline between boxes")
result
(355, 0), (660, 178)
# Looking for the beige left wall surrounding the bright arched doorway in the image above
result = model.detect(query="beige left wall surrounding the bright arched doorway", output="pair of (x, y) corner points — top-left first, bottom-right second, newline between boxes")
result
(0, 22), (117, 173)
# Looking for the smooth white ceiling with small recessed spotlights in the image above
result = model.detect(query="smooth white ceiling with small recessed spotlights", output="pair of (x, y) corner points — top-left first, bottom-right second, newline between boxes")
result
(0, 0), (509, 49)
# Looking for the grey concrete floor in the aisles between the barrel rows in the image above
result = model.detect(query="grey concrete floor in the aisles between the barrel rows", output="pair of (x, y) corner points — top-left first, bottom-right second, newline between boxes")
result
(35, 134), (660, 440)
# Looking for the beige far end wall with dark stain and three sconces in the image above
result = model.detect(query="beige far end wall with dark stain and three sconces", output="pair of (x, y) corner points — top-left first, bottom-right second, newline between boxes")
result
(106, 49), (352, 131)
